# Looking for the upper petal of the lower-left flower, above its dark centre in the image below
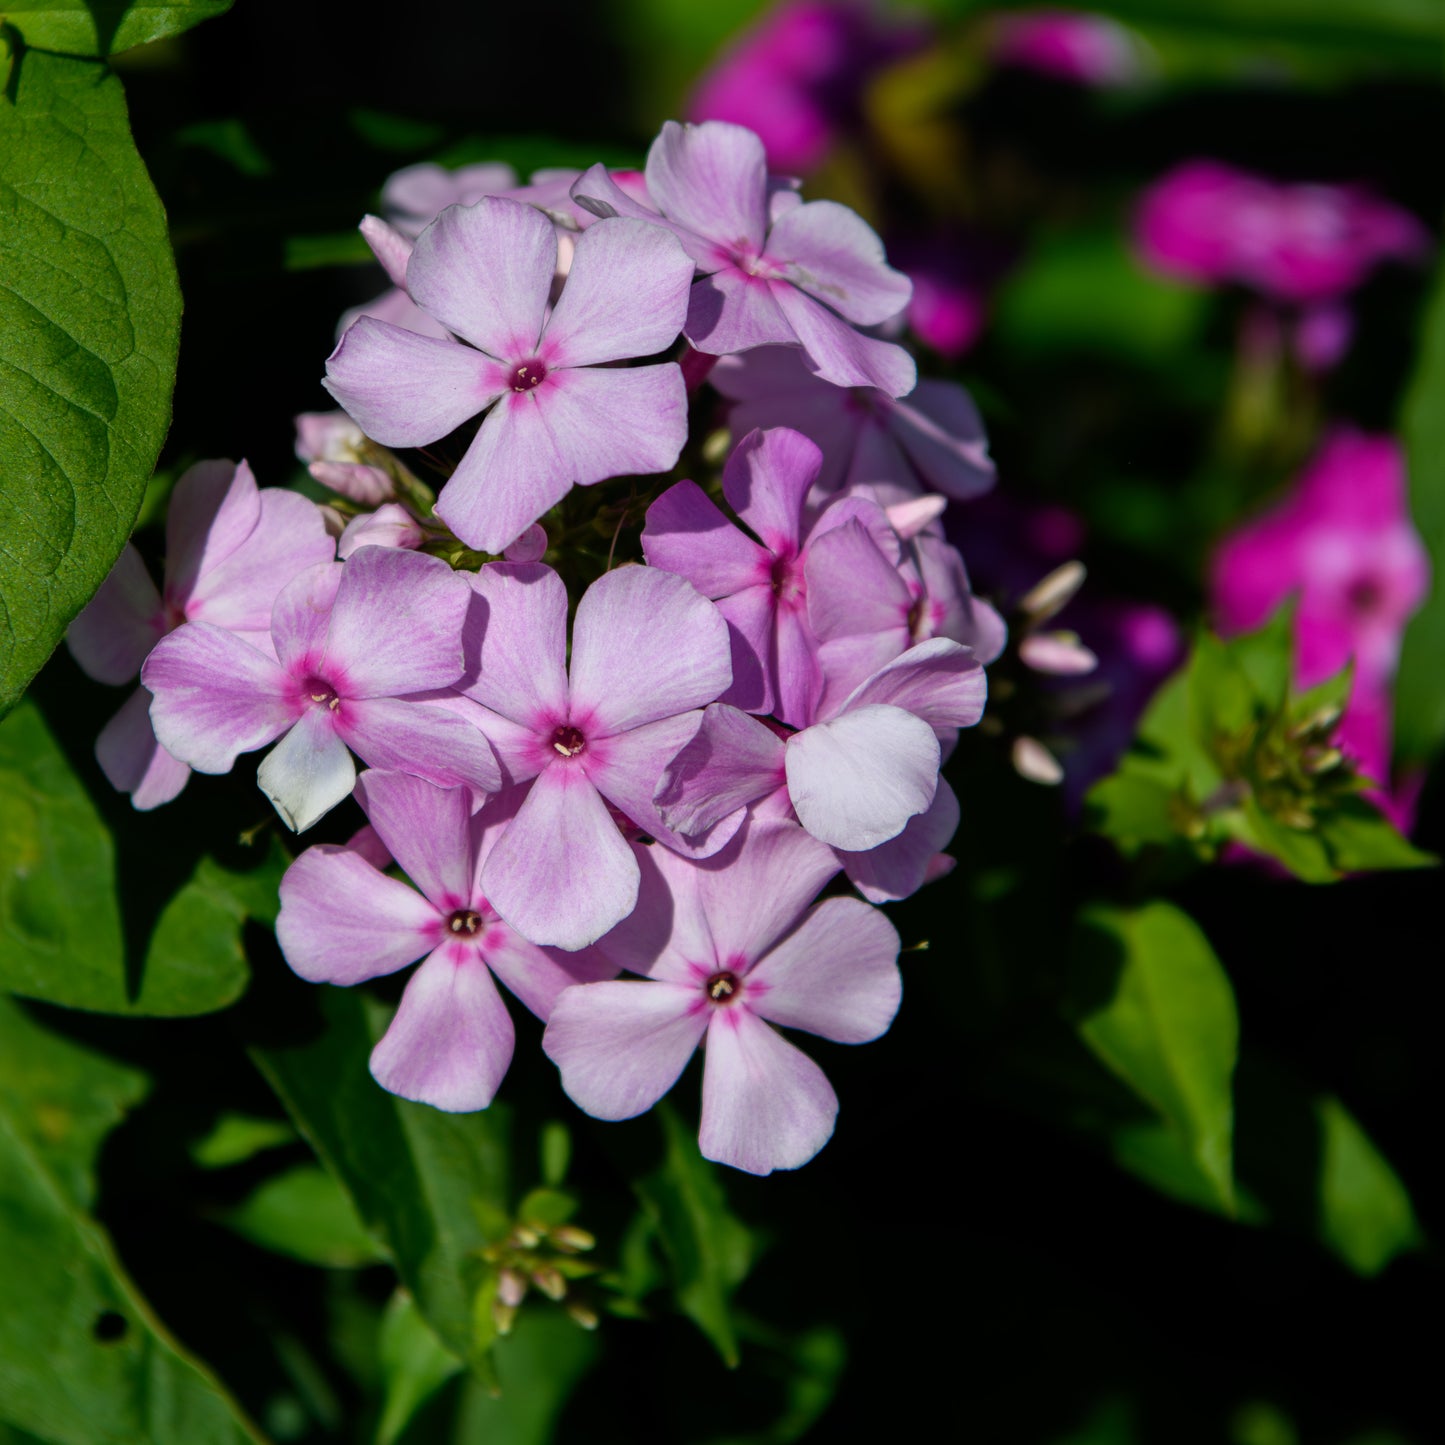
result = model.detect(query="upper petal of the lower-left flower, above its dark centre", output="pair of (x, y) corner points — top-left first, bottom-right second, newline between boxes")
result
(355, 769), (471, 913)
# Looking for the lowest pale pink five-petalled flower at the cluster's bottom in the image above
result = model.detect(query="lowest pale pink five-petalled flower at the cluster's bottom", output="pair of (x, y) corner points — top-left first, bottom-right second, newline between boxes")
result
(542, 821), (902, 1175)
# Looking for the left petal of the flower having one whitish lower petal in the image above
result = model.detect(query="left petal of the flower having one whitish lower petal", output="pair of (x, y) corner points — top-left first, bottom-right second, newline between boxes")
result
(140, 623), (295, 773)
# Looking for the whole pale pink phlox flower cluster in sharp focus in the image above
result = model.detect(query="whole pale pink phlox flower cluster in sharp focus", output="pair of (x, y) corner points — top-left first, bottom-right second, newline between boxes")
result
(71, 121), (1006, 1173)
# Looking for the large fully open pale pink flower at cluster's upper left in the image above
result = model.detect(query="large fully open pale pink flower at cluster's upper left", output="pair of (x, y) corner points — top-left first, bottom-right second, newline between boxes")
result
(325, 197), (692, 552)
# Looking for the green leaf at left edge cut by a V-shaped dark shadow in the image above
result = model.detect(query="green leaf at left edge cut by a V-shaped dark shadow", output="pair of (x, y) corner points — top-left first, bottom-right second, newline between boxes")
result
(0, 702), (286, 1017)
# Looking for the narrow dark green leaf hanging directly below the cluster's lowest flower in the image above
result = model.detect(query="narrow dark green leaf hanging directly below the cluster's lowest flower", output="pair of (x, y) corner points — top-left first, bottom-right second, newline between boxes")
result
(633, 1101), (753, 1366)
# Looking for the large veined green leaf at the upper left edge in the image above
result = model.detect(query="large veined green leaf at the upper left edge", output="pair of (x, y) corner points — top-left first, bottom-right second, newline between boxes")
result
(0, 48), (181, 717)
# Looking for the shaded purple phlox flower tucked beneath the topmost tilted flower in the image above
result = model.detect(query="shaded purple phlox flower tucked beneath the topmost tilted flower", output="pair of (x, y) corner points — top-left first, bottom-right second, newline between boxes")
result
(709, 347), (994, 507)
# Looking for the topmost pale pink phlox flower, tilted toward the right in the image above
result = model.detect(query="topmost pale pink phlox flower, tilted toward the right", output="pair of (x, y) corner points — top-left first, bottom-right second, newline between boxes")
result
(572, 120), (918, 396)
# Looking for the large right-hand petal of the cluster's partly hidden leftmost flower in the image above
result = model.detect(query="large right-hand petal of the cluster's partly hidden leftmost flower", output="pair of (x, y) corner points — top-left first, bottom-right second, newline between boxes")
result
(185, 491), (335, 631)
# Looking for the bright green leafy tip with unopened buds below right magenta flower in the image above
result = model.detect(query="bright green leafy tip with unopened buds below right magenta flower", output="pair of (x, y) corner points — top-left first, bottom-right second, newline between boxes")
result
(1088, 607), (1435, 883)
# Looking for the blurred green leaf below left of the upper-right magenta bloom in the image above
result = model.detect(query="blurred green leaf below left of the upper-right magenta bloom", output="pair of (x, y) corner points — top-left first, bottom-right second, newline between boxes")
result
(996, 227), (1209, 366)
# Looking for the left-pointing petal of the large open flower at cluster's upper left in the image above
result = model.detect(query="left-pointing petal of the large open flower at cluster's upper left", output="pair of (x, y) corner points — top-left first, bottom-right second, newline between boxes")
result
(321, 320), (508, 447)
